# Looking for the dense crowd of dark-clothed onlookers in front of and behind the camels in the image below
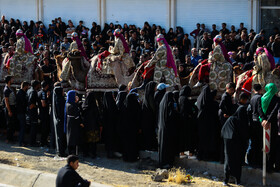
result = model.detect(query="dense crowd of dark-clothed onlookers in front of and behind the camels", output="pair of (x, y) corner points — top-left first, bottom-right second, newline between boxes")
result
(0, 16), (280, 184)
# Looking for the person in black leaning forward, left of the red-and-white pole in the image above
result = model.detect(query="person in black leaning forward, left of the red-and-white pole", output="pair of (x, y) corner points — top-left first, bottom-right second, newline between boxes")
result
(221, 106), (249, 184)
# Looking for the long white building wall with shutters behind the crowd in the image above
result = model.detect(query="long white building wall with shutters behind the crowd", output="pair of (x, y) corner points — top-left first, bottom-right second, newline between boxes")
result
(0, 0), (280, 36)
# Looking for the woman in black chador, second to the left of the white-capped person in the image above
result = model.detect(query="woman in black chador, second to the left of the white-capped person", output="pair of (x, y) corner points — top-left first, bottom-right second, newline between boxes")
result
(122, 93), (141, 162)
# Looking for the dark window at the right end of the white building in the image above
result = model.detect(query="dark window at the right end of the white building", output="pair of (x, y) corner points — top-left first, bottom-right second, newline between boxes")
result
(260, 0), (280, 36)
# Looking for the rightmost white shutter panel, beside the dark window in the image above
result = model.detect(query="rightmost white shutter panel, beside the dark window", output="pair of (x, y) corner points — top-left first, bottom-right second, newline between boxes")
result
(176, 0), (250, 36)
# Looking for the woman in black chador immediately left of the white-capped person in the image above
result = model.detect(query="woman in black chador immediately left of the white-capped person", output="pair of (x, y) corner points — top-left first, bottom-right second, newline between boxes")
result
(141, 81), (157, 150)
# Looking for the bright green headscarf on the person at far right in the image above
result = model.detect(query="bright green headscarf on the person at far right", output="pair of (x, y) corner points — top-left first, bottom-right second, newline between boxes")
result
(261, 83), (278, 114)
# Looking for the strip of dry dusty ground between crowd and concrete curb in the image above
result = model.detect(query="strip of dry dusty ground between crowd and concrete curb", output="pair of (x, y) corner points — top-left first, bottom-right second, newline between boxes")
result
(0, 141), (245, 187)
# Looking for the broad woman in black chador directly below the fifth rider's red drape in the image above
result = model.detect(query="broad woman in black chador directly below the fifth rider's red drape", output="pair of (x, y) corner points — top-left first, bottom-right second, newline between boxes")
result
(197, 86), (220, 160)
